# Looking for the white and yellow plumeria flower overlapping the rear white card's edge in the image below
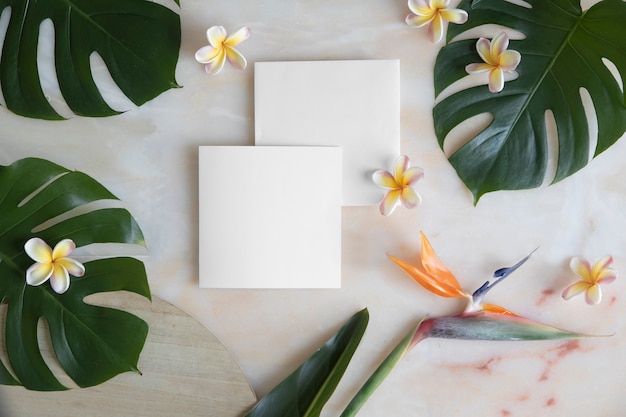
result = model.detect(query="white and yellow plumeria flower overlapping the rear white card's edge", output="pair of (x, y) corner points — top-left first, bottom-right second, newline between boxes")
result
(372, 155), (424, 216)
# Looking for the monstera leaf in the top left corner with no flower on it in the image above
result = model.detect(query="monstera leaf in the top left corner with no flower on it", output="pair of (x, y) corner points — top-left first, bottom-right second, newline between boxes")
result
(0, 0), (180, 119)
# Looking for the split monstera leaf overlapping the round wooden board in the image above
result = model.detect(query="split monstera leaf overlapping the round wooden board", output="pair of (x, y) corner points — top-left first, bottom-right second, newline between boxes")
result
(0, 159), (150, 390)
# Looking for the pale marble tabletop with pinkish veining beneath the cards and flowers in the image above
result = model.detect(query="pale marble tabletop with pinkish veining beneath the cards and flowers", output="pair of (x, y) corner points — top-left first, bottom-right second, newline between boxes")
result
(0, 0), (626, 417)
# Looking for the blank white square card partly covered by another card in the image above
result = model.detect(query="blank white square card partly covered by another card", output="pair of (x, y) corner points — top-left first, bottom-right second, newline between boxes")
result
(254, 60), (400, 206)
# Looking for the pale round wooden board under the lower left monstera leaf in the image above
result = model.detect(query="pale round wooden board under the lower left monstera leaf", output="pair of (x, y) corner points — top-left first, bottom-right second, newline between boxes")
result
(0, 293), (256, 417)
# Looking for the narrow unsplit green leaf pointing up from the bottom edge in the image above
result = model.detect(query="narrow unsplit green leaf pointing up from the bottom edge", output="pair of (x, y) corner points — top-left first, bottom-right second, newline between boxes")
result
(246, 309), (369, 417)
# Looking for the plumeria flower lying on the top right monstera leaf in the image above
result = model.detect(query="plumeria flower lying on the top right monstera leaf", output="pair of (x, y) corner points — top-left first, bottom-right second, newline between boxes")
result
(465, 32), (522, 93)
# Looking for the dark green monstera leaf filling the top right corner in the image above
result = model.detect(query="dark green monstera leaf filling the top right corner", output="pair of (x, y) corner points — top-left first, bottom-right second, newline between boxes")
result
(433, 0), (626, 202)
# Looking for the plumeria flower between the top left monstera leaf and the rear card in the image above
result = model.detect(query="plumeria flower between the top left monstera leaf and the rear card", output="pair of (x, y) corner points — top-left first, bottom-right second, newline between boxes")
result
(196, 26), (250, 75)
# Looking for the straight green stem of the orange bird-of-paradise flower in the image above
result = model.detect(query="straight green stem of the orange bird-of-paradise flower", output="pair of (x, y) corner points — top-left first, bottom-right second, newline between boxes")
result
(341, 319), (427, 417)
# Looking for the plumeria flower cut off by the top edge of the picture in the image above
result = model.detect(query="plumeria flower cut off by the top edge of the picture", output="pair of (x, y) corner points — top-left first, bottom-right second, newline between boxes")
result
(406, 0), (467, 42)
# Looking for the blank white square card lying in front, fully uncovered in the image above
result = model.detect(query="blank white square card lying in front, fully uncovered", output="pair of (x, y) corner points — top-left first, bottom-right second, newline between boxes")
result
(199, 146), (341, 288)
